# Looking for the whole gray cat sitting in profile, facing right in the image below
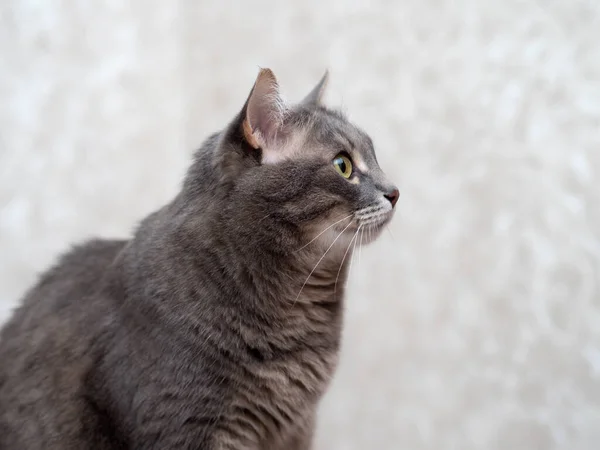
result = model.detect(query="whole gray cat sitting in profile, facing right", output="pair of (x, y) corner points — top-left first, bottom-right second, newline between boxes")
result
(0, 69), (398, 450)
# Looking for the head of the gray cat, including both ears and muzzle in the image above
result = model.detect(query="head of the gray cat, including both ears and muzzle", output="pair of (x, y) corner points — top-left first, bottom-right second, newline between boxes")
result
(211, 69), (399, 253)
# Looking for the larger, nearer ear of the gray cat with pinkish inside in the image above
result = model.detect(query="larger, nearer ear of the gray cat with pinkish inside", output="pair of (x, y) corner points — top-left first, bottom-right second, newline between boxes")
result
(243, 69), (286, 148)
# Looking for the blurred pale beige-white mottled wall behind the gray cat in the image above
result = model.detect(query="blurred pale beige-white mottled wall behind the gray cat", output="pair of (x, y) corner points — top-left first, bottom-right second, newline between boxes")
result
(0, 0), (600, 450)
